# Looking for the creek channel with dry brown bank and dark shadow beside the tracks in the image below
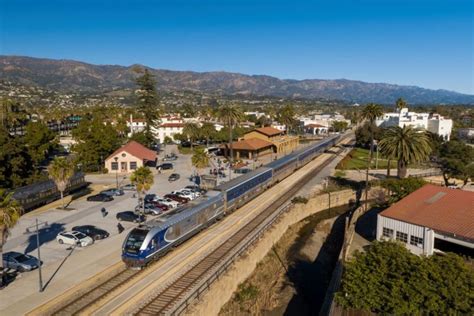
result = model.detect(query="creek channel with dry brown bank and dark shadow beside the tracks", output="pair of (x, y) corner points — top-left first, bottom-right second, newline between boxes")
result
(219, 206), (348, 316)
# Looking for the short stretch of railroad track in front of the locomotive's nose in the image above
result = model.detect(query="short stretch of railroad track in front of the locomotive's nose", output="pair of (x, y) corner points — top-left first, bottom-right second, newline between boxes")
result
(50, 265), (141, 316)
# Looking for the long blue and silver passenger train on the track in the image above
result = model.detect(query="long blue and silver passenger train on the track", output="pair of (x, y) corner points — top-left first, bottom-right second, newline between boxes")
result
(122, 135), (341, 267)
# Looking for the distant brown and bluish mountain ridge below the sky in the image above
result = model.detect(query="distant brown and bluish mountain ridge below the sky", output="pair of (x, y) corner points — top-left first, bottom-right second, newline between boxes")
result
(0, 56), (474, 104)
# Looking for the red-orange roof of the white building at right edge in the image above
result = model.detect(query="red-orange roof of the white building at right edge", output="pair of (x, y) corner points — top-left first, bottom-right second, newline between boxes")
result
(380, 184), (474, 241)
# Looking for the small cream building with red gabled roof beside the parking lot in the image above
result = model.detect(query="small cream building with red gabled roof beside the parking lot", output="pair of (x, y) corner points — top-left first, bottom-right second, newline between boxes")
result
(105, 141), (157, 173)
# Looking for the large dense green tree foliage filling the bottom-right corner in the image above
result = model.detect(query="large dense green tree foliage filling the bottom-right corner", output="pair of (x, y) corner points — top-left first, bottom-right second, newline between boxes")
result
(336, 242), (474, 315)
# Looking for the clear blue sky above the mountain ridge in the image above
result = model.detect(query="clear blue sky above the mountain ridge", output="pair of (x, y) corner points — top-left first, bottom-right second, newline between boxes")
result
(0, 0), (474, 94)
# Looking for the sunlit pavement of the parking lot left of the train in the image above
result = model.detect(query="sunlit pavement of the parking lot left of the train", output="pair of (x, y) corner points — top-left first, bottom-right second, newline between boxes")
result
(0, 151), (230, 312)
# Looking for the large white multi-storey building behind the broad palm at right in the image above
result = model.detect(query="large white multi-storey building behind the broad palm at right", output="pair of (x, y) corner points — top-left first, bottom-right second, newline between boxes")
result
(375, 108), (453, 140)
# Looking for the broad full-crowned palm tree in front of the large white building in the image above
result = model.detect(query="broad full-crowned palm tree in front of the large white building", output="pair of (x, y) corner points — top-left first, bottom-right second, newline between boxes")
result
(379, 126), (431, 178)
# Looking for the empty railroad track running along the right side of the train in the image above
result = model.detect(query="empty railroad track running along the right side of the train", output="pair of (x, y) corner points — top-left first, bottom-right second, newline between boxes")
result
(133, 142), (343, 315)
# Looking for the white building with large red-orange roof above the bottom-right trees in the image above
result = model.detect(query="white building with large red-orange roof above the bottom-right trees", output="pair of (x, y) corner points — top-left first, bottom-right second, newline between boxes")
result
(377, 184), (474, 256)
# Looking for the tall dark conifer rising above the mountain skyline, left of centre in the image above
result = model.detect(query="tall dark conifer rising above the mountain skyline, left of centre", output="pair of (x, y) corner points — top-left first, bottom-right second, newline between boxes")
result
(136, 69), (160, 146)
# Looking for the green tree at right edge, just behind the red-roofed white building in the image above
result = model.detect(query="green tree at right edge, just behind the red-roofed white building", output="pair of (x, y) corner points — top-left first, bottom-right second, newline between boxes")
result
(438, 140), (474, 186)
